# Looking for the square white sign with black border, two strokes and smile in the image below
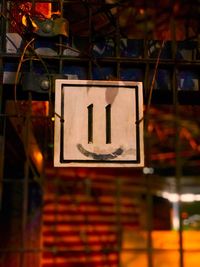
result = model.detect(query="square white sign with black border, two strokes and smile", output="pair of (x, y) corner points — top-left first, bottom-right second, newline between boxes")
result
(54, 79), (144, 167)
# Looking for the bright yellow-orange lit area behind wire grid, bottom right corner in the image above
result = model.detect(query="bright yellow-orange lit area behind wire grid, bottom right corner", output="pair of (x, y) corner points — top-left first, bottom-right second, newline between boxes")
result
(121, 231), (200, 267)
